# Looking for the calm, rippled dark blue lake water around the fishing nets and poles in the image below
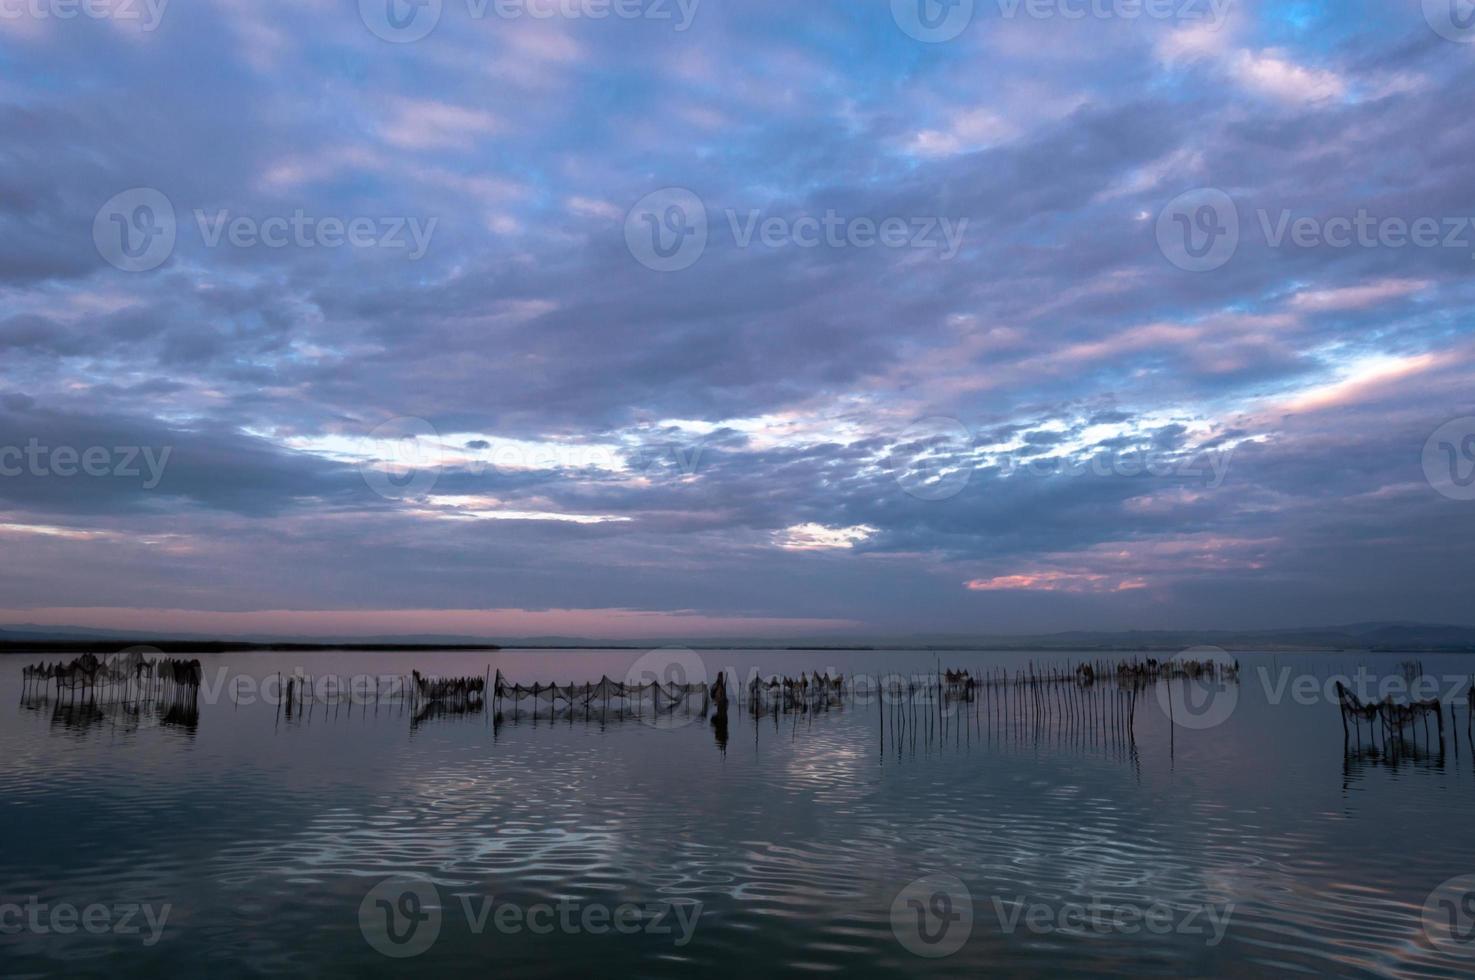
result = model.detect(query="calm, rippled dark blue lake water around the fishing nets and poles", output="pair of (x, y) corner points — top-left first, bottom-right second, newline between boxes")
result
(0, 651), (1475, 977)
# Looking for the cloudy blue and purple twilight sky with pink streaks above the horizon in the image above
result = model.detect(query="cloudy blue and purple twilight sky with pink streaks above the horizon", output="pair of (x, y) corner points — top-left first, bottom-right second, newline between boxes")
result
(0, 0), (1475, 638)
